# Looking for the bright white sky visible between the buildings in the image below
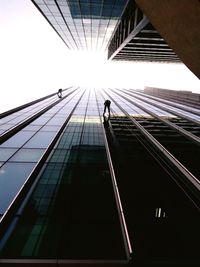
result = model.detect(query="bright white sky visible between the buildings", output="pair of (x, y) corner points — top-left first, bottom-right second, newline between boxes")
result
(0, 0), (200, 112)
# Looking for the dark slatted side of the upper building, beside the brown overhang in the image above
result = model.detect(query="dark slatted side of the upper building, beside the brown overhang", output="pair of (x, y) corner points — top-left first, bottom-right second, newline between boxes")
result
(108, 0), (180, 62)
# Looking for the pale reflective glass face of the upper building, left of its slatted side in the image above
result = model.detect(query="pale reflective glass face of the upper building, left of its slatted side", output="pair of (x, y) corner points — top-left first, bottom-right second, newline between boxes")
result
(32, 0), (127, 52)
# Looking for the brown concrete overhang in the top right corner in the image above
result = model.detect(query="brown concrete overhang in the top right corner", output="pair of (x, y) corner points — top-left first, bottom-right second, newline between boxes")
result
(135, 0), (200, 78)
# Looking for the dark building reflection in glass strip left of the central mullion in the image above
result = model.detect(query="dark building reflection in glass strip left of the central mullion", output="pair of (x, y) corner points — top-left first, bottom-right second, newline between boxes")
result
(3, 146), (126, 260)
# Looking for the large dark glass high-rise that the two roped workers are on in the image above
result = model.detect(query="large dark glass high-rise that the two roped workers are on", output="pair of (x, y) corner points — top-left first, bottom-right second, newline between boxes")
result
(0, 87), (200, 266)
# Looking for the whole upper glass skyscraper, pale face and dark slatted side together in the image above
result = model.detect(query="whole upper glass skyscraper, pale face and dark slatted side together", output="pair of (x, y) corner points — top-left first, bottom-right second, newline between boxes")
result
(32, 0), (180, 62)
